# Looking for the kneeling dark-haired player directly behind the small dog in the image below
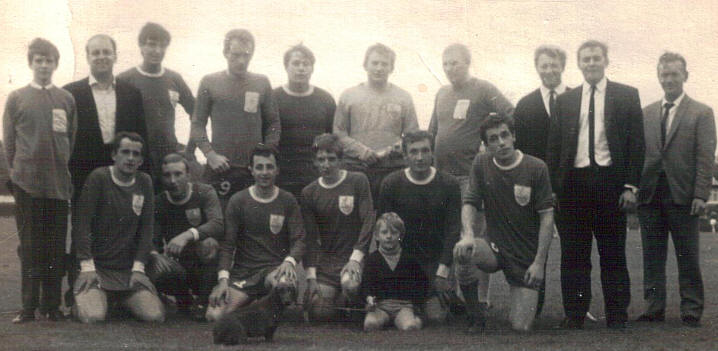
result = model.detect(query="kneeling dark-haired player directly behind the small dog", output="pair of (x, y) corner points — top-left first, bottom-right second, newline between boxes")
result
(207, 144), (305, 321)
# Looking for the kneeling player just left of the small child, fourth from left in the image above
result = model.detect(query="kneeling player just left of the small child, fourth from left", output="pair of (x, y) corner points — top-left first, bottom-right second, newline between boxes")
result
(300, 134), (375, 320)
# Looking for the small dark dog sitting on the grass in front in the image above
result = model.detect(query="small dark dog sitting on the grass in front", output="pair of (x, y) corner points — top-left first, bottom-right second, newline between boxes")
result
(213, 283), (297, 345)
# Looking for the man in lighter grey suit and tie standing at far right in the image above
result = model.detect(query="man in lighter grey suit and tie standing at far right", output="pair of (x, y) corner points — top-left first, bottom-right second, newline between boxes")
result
(638, 53), (716, 327)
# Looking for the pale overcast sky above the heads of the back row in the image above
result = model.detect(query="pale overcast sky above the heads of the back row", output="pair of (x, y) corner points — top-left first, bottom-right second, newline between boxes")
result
(0, 0), (718, 146)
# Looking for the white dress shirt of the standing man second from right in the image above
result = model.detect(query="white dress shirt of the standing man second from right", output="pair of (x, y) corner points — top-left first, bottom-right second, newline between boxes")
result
(573, 77), (611, 168)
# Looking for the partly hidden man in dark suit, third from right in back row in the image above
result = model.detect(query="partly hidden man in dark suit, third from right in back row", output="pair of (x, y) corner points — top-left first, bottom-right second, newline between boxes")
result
(514, 45), (568, 160)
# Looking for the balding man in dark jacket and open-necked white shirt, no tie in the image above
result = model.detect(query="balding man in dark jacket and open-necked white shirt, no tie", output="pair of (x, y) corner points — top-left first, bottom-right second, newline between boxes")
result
(63, 34), (150, 306)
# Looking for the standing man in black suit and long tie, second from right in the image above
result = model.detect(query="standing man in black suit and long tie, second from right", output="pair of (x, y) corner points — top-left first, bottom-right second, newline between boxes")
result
(547, 40), (645, 329)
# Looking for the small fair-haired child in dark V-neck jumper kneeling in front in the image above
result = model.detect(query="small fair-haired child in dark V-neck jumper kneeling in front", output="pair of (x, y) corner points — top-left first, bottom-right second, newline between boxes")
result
(361, 212), (429, 331)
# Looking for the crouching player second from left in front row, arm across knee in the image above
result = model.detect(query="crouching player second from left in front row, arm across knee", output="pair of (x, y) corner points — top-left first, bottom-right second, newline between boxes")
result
(150, 153), (224, 320)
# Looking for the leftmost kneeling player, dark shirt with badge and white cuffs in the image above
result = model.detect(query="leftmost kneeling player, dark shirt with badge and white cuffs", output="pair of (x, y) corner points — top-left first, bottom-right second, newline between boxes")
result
(72, 132), (164, 323)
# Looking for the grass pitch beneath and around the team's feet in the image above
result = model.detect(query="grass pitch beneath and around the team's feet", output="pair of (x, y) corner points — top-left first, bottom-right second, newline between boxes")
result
(0, 218), (718, 351)
